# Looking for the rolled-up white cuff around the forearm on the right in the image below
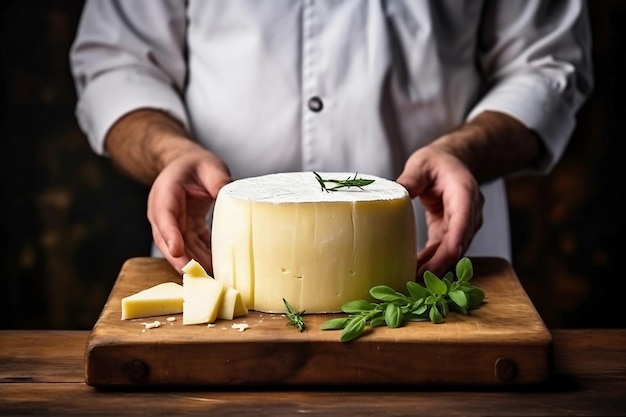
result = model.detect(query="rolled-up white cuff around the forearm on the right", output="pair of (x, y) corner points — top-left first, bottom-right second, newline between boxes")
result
(468, 74), (576, 174)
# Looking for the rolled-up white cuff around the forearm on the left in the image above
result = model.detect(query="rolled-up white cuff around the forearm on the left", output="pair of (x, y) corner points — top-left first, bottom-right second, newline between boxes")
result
(76, 70), (189, 155)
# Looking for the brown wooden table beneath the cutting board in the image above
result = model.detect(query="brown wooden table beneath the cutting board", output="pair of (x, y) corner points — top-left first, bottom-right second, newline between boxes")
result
(0, 329), (626, 417)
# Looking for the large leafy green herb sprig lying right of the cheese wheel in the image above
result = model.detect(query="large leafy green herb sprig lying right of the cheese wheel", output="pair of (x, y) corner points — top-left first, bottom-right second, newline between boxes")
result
(322, 258), (485, 342)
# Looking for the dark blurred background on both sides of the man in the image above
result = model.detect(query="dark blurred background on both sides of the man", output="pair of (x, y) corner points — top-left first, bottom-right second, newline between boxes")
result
(0, 0), (626, 329)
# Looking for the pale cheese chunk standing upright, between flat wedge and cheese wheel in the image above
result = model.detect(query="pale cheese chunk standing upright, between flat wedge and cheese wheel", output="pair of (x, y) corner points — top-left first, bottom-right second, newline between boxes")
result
(183, 274), (226, 325)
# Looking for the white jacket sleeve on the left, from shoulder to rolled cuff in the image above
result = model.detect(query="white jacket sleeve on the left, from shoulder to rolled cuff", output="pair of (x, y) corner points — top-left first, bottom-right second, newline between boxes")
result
(70, 0), (188, 155)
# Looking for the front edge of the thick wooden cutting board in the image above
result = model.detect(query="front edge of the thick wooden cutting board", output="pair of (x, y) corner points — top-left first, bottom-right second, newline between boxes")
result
(85, 338), (553, 388)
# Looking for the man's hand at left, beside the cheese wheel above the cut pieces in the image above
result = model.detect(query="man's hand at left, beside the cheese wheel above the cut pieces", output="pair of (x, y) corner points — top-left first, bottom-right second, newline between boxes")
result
(148, 150), (231, 272)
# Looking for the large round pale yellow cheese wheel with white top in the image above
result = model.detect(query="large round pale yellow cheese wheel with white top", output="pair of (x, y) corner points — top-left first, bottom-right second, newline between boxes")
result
(212, 172), (417, 313)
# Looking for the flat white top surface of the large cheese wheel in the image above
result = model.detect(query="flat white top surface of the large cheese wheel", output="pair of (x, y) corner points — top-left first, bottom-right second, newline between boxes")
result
(220, 171), (408, 204)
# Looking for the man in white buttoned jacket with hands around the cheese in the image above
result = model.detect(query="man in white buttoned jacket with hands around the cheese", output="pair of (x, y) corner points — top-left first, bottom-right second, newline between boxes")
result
(70, 0), (592, 276)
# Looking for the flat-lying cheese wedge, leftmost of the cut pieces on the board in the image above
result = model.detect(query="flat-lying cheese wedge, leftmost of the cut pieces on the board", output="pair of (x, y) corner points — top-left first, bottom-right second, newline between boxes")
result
(122, 282), (183, 320)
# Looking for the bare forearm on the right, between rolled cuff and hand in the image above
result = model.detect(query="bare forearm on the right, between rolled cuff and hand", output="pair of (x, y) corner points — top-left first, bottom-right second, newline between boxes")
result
(431, 111), (544, 182)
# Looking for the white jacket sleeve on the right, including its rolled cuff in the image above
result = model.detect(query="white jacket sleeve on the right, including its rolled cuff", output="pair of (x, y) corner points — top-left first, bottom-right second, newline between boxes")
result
(468, 0), (593, 173)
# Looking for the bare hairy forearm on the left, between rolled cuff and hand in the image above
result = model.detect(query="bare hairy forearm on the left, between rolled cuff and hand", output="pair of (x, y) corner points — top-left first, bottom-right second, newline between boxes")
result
(105, 109), (200, 185)
